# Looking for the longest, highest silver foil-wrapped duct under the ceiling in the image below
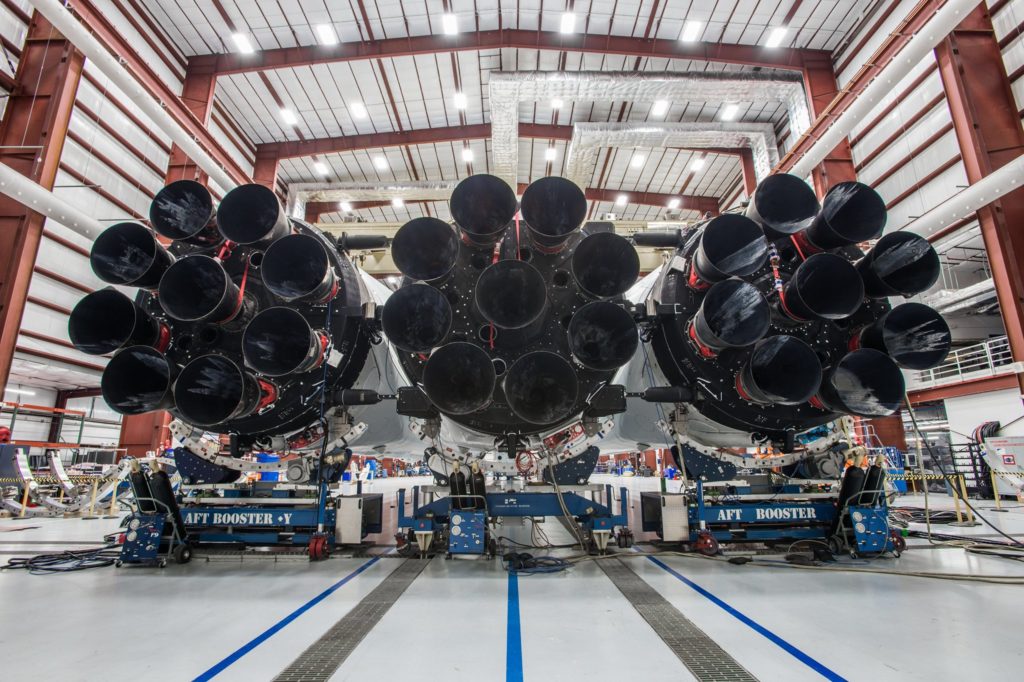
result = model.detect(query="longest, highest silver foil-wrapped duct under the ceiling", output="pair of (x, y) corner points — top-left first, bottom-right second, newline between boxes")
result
(487, 71), (810, 187)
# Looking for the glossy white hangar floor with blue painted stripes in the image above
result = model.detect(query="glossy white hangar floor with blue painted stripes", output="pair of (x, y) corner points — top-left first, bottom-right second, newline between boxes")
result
(0, 477), (1024, 682)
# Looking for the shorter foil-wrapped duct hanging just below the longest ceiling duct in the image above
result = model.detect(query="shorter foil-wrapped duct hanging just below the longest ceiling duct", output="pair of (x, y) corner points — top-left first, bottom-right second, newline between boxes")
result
(565, 121), (778, 188)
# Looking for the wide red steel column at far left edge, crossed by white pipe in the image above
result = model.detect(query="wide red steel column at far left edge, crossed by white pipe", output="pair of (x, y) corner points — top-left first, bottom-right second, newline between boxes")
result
(0, 12), (84, 391)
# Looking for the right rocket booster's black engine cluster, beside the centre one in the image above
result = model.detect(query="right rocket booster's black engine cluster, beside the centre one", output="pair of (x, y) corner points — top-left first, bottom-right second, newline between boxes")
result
(634, 174), (950, 449)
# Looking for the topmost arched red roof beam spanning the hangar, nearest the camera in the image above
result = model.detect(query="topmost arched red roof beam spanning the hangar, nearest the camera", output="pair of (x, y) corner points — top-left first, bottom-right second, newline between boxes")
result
(188, 29), (831, 75)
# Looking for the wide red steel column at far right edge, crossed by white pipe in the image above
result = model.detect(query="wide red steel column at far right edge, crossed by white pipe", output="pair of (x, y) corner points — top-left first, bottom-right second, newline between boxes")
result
(935, 3), (1024, 392)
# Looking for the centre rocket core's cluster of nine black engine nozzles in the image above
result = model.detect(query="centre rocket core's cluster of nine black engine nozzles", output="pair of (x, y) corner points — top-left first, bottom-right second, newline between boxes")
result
(382, 175), (640, 436)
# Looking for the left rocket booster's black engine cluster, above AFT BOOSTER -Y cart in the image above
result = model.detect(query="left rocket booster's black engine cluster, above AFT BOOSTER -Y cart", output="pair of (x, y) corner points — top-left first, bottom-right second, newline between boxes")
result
(69, 180), (371, 446)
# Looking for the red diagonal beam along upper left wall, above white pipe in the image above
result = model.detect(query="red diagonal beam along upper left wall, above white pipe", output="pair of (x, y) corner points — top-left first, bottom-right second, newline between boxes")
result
(71, 0), (252, 183)
